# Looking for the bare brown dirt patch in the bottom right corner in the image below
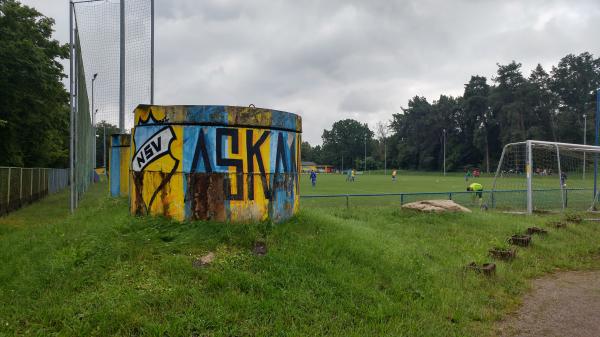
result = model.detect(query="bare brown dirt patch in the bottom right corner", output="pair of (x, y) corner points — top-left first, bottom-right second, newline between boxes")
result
(497, 271), (600, 337)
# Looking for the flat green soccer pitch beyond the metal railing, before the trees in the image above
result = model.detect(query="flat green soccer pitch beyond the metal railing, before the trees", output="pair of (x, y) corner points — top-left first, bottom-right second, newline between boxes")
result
(300, 172), (593, 211)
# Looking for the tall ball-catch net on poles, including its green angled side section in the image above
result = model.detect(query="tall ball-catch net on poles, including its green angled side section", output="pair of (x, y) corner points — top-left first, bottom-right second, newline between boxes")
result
(70, 0), (153, 207)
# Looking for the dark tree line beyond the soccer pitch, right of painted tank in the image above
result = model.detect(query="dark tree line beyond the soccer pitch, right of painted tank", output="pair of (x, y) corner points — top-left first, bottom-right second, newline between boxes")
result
(302, 52), (600, 171)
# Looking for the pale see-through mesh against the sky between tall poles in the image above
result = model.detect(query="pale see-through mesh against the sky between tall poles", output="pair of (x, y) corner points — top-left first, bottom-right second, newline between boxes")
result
(75, 0), (151, 132)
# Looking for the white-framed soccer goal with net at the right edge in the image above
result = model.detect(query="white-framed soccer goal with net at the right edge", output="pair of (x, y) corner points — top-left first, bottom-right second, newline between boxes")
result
(487, 140), (600, 213)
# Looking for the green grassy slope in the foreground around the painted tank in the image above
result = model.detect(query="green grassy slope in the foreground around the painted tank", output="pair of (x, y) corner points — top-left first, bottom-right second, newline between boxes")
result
(0, 176), (600, 336)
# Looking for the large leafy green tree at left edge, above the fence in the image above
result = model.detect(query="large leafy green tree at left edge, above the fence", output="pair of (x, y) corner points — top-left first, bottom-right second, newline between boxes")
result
(0, 0), (69, 167)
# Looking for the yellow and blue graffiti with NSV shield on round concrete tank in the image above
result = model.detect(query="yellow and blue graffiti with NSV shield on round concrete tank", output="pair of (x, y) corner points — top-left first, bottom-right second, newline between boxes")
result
(131, 106), (301, 221)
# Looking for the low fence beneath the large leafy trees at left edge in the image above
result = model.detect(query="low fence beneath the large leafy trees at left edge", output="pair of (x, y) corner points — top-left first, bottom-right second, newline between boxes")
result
(0, 167), (69, 215)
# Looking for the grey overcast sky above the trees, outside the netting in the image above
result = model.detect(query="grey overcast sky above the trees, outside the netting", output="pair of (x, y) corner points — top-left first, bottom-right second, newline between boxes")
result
(17, 0), (600, 145)
